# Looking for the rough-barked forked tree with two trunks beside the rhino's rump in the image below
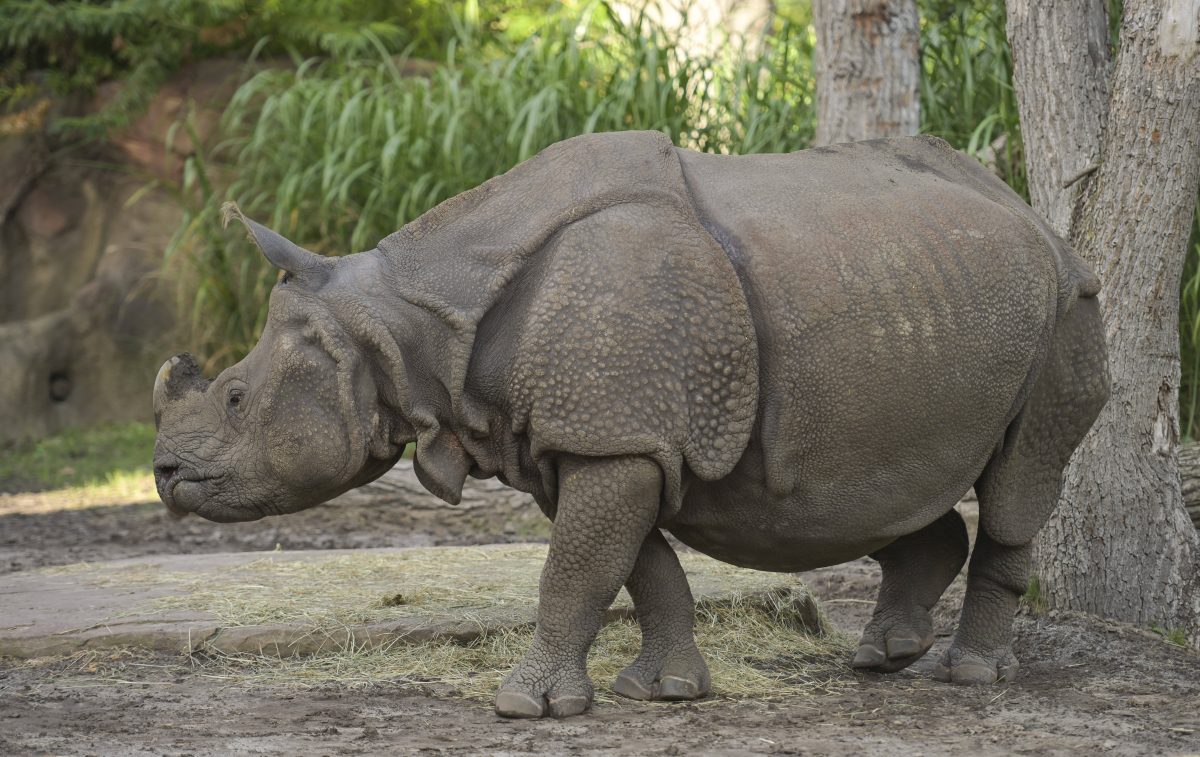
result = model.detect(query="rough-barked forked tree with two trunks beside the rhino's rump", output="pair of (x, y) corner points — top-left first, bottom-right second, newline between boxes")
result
(1009, 0), (1200, 645)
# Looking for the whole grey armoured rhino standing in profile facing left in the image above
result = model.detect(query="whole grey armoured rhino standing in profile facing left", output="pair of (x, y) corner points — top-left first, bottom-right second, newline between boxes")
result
(155, 132), (1109, 717)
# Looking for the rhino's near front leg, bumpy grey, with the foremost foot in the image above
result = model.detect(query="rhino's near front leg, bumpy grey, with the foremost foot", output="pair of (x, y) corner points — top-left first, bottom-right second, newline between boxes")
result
(496, 457), (661, 717)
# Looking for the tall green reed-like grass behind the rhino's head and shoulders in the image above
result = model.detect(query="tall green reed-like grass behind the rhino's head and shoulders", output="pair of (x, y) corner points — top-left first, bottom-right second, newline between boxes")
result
(174, 4), (814, 367)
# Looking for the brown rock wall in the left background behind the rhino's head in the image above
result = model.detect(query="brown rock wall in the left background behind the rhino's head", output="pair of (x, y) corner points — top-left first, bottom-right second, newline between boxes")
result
(0, 61), (238, 445)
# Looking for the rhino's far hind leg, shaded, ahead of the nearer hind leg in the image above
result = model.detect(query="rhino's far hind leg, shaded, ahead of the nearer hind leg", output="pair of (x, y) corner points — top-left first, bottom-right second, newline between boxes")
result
(852, 510), (968, 673)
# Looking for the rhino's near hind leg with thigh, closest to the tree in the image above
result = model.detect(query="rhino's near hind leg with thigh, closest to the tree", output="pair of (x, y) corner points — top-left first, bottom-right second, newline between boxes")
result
(934, 299), (1109, 684)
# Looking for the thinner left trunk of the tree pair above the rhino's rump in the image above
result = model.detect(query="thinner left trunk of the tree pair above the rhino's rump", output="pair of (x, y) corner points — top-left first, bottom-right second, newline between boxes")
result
(1006, 0), (1111, 239)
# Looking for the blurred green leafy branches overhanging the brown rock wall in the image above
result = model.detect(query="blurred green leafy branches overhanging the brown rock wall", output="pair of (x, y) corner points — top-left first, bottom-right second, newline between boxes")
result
(0, 0), (450, 137)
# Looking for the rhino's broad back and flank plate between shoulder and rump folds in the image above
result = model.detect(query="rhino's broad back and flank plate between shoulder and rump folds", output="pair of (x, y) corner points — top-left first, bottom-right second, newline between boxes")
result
(679, 140), (1061, 539)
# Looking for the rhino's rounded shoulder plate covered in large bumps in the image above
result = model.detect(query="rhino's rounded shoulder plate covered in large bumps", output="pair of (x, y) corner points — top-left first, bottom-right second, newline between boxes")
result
(509, 196), (758, 518)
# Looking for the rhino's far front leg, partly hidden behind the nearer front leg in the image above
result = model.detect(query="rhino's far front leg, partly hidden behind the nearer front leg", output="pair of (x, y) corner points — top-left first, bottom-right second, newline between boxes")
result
(612, 529), (709, 699)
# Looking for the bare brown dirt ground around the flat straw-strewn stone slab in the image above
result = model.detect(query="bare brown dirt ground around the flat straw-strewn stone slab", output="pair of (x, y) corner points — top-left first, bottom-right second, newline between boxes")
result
(0, 491), (1200, 755)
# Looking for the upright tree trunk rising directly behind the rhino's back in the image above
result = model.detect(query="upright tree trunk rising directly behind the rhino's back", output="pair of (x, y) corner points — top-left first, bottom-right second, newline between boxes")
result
(812, 0), (920, 145)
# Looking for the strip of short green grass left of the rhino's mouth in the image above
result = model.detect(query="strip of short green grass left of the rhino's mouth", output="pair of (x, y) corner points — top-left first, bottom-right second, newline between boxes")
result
(0, 423), (155, 492)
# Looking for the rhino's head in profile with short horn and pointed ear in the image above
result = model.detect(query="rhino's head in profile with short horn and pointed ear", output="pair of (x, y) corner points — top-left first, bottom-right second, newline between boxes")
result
(154, 205), (407, 522)
